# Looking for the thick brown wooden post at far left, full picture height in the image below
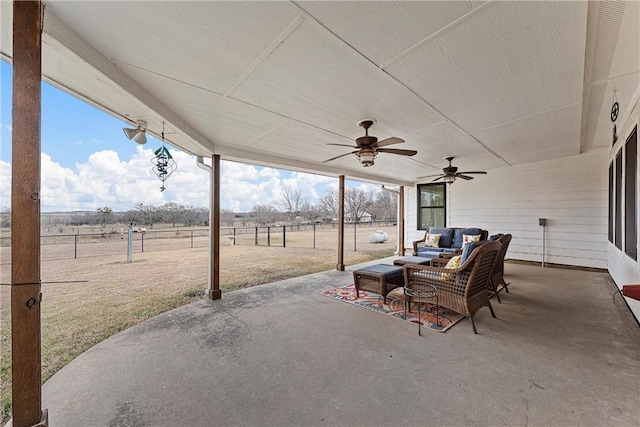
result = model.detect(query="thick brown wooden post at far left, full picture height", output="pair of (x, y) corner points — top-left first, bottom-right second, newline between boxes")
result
(11, 1), (47, 427)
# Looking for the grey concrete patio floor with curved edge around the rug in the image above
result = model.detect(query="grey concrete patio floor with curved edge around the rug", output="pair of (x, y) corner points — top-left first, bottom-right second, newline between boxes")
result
(43, 259), (640, 426)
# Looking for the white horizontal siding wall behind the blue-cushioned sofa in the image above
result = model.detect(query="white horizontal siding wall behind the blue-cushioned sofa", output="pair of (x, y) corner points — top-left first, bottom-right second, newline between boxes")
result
(405, 149), (608, 268)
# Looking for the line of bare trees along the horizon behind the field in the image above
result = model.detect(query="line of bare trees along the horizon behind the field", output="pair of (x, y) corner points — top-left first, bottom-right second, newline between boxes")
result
(0, 186), (397, 228)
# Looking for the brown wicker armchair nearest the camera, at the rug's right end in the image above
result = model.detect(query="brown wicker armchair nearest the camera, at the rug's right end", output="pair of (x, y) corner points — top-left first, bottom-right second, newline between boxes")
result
(404, 241), (501, 334)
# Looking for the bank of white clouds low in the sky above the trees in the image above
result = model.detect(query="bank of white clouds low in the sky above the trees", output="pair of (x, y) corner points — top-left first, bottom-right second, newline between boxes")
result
(0, 146), (378, 212)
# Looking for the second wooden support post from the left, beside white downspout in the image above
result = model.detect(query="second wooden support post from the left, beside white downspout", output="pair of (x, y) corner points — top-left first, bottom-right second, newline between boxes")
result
(207, 154), (222, 300)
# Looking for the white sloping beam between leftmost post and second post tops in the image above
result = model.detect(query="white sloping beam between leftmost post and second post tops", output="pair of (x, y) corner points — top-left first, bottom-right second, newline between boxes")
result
(40, 8), (215, 153)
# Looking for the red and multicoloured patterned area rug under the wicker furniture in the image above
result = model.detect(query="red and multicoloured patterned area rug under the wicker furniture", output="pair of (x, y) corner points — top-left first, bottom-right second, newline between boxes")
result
(322, 284), (464, 332)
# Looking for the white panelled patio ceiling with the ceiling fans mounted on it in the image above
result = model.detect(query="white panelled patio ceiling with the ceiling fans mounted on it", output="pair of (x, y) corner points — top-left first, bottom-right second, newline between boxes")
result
(1, 1), (640, 184)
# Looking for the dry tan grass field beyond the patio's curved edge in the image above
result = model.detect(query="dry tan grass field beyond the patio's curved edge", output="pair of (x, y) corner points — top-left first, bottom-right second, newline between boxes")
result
(0, 226), (396, 420)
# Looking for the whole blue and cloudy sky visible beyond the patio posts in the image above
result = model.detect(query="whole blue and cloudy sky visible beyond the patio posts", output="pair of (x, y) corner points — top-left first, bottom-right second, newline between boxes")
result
(0, 61), (379, 212)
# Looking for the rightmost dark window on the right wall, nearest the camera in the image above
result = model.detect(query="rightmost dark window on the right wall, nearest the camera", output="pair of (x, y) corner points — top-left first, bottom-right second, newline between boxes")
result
(624, 127), (638, 259)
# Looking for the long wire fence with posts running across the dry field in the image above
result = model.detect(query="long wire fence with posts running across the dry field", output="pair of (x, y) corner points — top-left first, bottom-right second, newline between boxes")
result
(0, 221), (396, 264)
